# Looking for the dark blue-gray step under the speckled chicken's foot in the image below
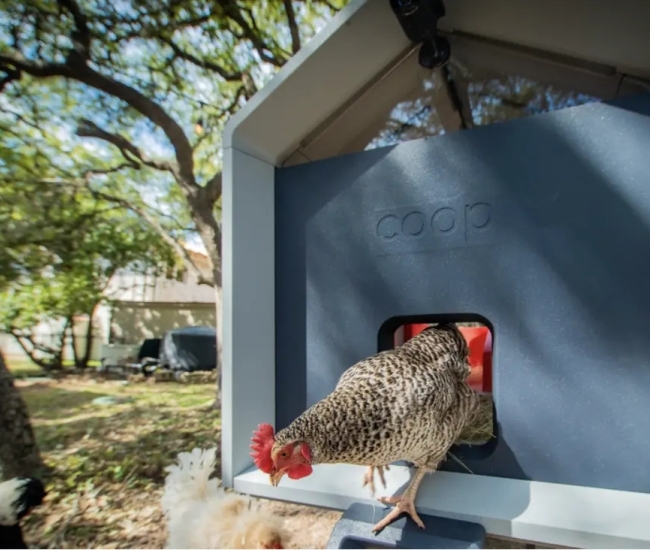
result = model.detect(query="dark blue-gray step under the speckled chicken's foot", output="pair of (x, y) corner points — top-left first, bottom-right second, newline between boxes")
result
(326, 502), (487, 548)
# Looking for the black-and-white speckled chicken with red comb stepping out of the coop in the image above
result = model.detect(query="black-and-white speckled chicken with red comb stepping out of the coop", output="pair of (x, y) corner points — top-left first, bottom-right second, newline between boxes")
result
(251, 323), (478, 532)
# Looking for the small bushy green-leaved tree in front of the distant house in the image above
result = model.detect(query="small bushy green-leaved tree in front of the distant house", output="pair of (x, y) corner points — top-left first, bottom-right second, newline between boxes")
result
(0, 179), (174, 369)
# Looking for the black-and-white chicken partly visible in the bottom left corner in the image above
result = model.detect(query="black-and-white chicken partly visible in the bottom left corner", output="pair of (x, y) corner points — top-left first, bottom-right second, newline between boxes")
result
(0, 477), (45, 548)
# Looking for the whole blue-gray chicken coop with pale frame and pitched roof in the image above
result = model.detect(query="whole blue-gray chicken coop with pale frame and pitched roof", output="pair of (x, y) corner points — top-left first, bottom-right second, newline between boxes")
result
(222, 0), (650, 548)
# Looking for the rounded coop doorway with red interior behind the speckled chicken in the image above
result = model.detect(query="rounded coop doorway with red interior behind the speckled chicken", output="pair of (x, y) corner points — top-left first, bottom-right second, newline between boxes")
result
(378, 314), (497, 450)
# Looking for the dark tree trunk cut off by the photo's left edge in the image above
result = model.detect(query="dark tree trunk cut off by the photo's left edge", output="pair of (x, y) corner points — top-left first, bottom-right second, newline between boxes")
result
(0, 351), (43, 479)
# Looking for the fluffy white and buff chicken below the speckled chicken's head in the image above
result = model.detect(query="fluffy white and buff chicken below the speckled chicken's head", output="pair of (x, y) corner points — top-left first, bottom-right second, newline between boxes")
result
(161, 448), (285, 548)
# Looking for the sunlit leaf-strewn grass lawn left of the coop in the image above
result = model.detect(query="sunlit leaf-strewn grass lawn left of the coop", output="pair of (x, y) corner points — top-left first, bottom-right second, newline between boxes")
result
(16, 378), (220, 548)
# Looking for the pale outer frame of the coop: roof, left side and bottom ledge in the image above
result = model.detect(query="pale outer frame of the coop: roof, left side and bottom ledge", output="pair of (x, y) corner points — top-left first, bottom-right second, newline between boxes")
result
(222, 0), (650, 548)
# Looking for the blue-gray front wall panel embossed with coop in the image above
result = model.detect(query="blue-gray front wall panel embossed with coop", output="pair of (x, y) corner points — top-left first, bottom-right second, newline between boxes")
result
(275, 94), (650, 493)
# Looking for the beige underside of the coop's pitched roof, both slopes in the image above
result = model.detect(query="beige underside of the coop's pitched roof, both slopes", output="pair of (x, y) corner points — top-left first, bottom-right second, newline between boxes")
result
(224, 0), (650, 165)
